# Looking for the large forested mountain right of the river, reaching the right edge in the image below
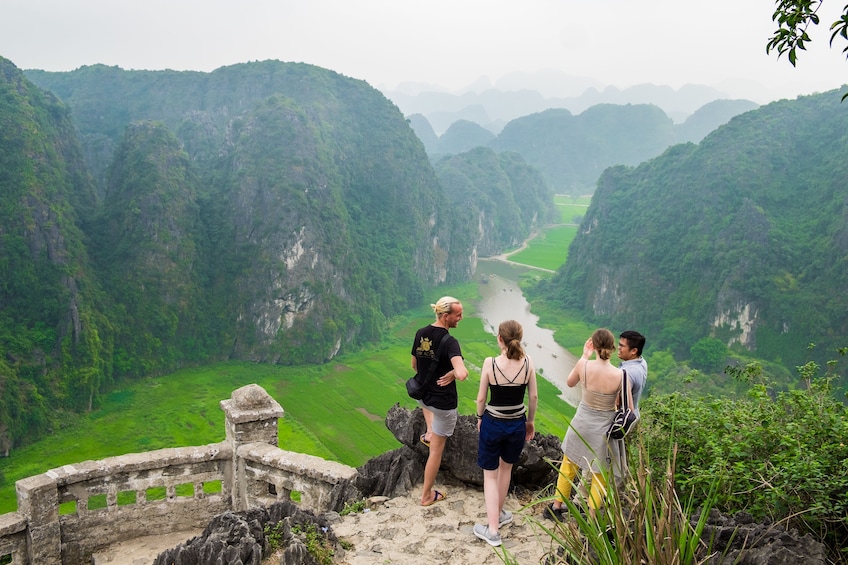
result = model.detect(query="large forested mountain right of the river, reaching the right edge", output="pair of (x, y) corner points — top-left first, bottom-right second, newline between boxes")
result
(544, 88), (848, 378)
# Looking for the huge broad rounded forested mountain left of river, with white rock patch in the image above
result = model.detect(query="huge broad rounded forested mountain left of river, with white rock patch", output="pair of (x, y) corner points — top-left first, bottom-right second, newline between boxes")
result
(21, 61), (458, 369)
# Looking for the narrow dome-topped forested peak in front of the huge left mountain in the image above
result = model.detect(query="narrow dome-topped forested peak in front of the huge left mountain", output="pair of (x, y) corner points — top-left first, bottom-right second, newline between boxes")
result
(88, 122), (209, 375)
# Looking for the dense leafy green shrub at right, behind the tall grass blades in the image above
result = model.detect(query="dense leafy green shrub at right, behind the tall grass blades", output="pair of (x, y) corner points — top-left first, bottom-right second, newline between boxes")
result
(639, 350), (848, 558)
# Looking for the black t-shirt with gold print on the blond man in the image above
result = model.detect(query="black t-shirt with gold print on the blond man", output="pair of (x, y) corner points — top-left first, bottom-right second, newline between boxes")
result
(412, 325), (462, 410)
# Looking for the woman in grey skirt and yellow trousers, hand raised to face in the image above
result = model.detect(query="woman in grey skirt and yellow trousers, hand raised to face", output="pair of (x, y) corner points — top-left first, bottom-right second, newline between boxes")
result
(547, 328), (632, 519)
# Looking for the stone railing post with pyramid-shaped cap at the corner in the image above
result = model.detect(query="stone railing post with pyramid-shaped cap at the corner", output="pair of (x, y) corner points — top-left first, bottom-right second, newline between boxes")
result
(221, 384), (283, 512)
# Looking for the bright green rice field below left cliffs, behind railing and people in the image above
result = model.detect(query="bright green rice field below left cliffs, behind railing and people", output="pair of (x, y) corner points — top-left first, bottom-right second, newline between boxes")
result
(0, 283), (574, 513)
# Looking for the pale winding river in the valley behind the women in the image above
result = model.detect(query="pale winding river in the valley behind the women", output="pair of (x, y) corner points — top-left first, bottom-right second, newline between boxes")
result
(476, 259), (580, 406)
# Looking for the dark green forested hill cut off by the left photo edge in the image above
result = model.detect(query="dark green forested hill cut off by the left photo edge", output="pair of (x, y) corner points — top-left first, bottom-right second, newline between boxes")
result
(0, 58), (110, 446)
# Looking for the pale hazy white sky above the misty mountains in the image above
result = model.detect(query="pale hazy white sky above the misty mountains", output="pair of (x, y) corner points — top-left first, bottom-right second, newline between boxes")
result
(0, 0), (848, 97)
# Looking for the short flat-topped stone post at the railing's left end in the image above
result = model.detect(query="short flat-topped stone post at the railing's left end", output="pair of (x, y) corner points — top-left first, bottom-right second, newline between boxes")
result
(15, 475), (62, 565)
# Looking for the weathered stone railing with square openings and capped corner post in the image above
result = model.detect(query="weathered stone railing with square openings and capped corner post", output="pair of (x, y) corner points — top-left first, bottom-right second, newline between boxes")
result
(0, 385), (356, 565)
